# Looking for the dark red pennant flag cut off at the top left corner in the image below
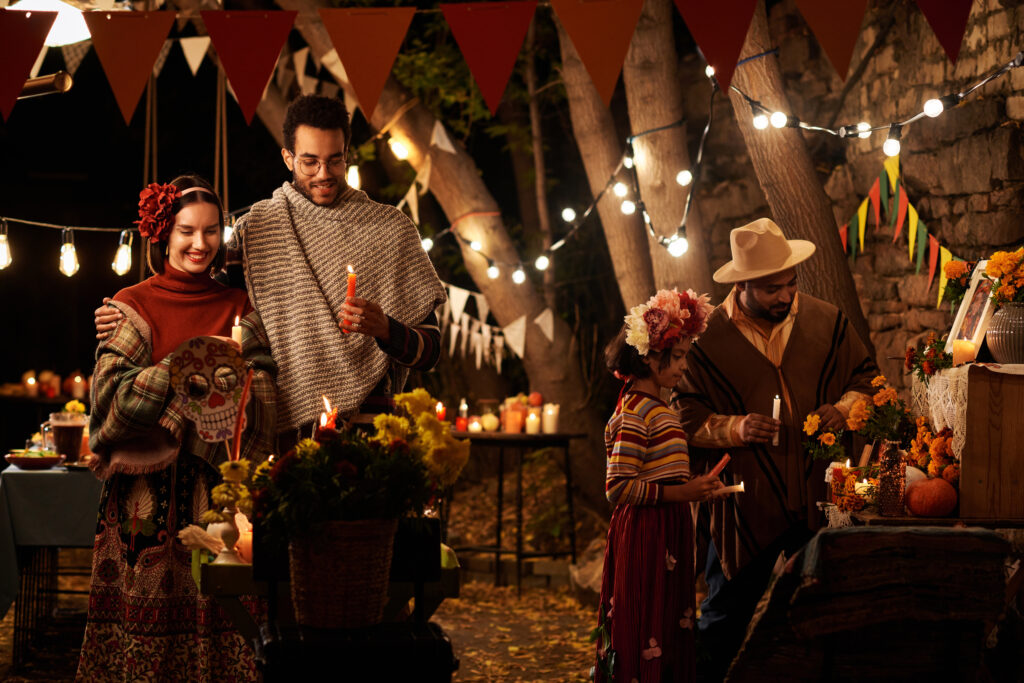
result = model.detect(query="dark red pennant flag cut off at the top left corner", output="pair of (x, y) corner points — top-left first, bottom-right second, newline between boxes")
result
(0, 9), (57, 121)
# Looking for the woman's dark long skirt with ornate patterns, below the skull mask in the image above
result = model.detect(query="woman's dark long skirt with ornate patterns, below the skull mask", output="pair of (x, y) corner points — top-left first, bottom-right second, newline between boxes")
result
(77, 455), (263, 683)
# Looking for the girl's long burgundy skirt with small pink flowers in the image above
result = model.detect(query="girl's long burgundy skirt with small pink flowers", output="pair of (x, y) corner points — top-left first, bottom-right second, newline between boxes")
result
(595, 503), (695, 683)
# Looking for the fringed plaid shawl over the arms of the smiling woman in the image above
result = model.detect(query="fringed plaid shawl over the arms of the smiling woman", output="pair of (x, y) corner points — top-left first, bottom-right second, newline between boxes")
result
(89, 301), (276, 479)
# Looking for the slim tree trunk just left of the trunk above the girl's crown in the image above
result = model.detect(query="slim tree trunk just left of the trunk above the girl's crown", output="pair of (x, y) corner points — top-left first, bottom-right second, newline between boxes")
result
(555, 17), (660, 309)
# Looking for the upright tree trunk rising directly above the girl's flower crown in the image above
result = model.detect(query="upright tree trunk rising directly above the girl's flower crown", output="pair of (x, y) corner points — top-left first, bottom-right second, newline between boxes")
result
(623, 0), (714, 292)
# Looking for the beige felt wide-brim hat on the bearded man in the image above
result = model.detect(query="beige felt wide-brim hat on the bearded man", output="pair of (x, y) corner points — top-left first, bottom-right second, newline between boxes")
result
(714, 218), (815, 284)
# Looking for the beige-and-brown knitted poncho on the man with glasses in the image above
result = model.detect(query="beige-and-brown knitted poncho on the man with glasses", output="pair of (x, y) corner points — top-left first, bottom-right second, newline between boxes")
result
(236, 182), (444, 430)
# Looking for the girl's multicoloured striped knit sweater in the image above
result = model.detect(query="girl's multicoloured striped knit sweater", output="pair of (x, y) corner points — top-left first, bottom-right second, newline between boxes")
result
(604, 391), (690, 505)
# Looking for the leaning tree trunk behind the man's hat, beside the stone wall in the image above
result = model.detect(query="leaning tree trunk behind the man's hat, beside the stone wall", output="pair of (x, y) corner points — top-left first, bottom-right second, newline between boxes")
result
(729, 0), (874, 355)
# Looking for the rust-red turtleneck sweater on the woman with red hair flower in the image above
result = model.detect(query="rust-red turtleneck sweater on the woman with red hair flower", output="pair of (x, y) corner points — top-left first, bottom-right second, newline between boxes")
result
(114, 263), (253, 365)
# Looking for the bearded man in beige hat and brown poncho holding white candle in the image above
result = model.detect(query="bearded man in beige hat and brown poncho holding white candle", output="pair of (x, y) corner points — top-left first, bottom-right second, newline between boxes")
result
(673, 218), (878, 680)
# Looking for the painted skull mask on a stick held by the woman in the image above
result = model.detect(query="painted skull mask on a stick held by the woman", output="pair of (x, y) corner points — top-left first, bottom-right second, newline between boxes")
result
(170, 337), (246, 442)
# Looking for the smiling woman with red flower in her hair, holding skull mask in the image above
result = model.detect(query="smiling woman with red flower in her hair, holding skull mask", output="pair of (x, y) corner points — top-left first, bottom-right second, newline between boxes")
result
(78, 175), (273, 681)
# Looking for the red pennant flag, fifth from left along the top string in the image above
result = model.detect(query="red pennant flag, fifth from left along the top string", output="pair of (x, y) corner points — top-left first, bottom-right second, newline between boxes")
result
(441, 0), (537, 115)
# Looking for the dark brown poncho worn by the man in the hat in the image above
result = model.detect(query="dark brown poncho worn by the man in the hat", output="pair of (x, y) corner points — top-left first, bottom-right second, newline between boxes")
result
(672, 293), (878, 578)
